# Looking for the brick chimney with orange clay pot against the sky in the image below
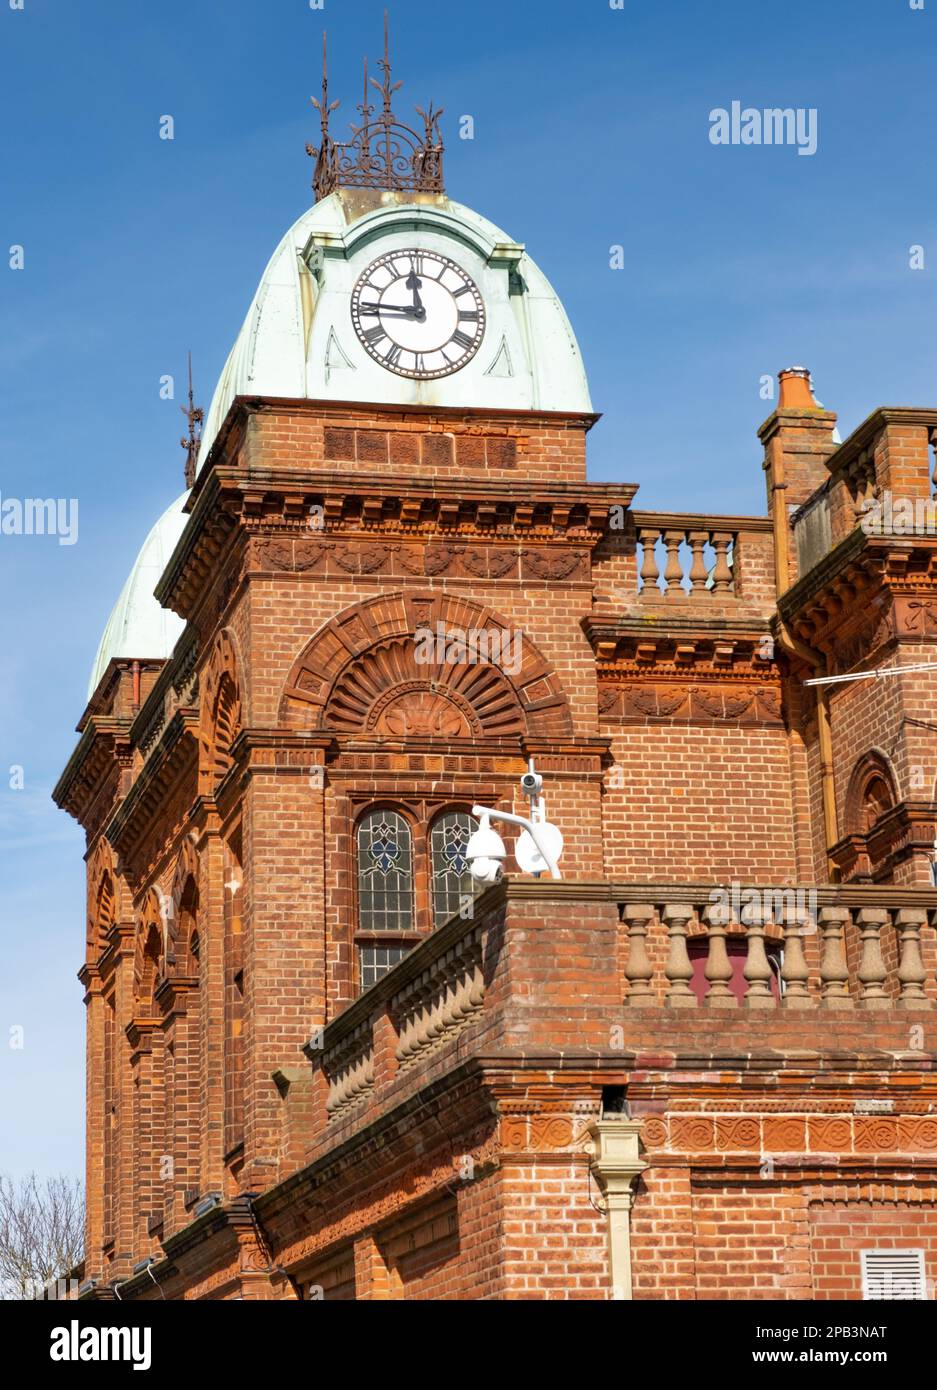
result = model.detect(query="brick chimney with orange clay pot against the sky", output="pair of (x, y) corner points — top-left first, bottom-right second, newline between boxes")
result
(758, 367), (838, 594)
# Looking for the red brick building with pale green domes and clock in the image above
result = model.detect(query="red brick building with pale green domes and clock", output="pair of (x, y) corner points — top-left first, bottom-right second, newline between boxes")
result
(56, 46), (937, 1300)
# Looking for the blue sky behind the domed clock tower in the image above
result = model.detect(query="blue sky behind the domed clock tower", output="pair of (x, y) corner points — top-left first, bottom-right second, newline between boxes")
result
(0, 0), (937, 1172)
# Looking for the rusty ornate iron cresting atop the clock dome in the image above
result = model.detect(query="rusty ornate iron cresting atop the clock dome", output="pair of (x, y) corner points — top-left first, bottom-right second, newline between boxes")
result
(306, 10), (445, 202)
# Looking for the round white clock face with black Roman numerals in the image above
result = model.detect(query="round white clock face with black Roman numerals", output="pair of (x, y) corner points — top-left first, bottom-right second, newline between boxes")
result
(352, 250), (485, 381)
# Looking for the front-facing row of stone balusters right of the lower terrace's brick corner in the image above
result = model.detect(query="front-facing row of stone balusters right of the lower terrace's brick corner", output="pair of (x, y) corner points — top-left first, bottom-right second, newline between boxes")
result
(621, 888), (937, 1011)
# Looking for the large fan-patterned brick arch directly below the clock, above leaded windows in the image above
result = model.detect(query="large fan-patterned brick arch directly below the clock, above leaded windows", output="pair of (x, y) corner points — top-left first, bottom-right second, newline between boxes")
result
(279, 594), (573, 738)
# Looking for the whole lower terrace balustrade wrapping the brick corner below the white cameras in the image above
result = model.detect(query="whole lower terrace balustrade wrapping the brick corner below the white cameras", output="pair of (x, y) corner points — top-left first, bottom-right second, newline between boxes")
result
(287, 878), (937, 1163)
